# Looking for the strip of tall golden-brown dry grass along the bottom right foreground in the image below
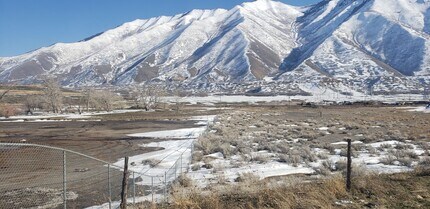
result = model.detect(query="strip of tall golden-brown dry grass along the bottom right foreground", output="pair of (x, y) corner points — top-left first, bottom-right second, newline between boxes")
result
(159, 171), (430, 209)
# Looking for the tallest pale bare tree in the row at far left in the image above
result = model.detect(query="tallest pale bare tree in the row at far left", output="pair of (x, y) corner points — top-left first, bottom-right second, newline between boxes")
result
(42, 77), (63, 113)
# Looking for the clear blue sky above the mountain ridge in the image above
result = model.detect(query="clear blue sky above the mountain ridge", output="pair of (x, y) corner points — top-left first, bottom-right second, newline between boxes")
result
(0, 0), (319, 57)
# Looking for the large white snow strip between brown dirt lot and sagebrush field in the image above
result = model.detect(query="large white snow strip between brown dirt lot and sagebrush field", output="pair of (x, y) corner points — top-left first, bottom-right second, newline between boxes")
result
(89, 115), (216, 209)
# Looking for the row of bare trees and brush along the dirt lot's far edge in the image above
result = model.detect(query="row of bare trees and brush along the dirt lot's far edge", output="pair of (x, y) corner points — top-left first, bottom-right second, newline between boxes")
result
(0, 77), (165, 118)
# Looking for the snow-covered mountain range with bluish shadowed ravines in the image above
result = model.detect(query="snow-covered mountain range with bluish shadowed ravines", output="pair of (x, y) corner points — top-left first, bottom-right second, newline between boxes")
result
(0, 0), (430, 94)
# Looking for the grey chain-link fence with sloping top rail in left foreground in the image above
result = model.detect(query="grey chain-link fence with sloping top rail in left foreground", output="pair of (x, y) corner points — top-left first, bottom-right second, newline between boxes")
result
(0, 141), (193, 208)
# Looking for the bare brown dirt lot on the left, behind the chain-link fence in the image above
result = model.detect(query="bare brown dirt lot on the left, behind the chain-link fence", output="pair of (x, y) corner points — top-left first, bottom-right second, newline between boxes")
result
(0, 107), (225, 208)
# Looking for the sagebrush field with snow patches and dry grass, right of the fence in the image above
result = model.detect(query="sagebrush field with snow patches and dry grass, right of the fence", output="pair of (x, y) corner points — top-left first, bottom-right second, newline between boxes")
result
(165, 104), (430, 208)
